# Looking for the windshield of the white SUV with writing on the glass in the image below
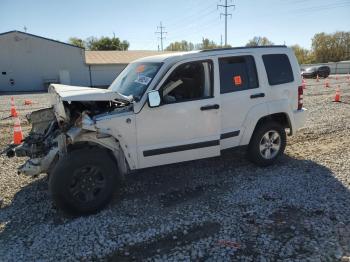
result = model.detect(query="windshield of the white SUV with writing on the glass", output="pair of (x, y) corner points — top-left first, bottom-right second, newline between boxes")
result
(109, 62), (162, 101)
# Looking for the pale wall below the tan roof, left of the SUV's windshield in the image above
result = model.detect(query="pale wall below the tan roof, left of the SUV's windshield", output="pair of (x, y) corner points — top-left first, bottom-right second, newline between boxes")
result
(90, 64), (127, 87)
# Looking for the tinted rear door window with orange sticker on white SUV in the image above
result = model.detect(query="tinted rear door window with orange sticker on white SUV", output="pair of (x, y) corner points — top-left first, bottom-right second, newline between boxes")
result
(219, 56), (259, 94)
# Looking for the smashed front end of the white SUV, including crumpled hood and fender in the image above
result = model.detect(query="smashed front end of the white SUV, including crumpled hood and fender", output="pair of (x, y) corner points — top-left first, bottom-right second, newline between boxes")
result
(6, 85), (131, 176)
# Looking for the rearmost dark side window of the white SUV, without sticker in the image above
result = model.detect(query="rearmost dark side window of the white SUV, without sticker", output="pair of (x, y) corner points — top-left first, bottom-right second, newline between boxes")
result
(263, 54), (294, 85)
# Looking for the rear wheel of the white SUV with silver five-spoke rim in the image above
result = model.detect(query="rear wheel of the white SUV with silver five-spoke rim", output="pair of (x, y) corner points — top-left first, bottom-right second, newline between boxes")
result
(248, 122), (287, 167)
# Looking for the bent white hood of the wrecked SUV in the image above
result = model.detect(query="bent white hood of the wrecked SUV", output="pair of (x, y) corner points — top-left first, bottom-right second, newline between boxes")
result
(49, 84), (131, 102)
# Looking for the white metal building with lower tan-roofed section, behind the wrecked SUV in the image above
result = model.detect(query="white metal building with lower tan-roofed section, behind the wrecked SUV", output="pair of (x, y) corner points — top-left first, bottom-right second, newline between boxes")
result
(0, 31), (171, 92)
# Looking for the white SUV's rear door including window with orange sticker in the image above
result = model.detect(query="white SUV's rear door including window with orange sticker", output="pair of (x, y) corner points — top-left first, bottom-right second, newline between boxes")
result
(218, 52), (267, 149)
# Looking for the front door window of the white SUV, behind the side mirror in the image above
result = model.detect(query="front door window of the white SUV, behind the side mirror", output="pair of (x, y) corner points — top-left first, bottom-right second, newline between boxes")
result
(160, 60), (213, 104)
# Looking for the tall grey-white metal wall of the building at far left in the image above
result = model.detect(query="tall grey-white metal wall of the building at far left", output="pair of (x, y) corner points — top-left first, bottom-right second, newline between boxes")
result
(0, 32), (90, 92)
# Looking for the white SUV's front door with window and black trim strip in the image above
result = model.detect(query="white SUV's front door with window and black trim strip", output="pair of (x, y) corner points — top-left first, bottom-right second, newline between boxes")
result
(136, 60), (220, 168)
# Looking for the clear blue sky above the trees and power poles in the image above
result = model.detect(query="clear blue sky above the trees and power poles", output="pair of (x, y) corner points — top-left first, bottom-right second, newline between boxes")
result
(0, 0), (350, 50)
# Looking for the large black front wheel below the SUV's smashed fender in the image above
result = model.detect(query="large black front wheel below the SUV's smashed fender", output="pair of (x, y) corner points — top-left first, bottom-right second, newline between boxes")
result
(49, 148), (118, 215)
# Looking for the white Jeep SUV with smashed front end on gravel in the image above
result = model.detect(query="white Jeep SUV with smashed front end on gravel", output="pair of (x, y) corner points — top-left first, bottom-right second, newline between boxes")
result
(7, 46), (305, 214)
